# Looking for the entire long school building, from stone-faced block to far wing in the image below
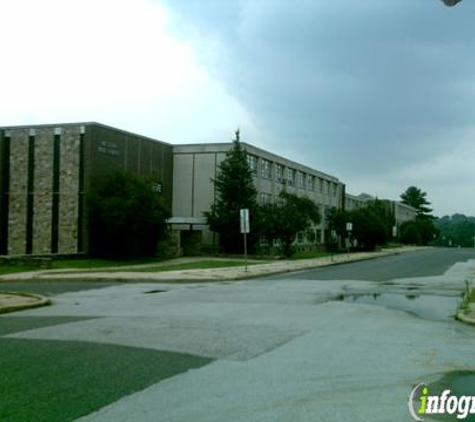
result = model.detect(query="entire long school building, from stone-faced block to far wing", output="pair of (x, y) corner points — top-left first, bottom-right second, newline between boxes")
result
(0, 123), (415, 255)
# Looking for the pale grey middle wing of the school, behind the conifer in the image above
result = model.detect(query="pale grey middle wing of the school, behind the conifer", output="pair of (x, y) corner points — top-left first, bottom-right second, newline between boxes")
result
(170, 142), (345, 244)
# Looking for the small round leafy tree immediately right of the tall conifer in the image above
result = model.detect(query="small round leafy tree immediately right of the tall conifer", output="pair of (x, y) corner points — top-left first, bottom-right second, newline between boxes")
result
(260, 190), (321, 257)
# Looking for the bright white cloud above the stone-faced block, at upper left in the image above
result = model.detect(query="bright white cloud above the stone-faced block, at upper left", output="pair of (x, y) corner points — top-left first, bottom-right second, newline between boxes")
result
(0, 0), (253, 143)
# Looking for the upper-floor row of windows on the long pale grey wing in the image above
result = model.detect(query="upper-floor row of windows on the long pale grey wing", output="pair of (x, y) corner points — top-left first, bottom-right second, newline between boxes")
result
(247, 154), (338, 196)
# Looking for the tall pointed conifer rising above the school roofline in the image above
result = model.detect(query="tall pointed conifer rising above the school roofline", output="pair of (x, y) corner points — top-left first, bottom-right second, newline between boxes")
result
(205, 130), (259, 253)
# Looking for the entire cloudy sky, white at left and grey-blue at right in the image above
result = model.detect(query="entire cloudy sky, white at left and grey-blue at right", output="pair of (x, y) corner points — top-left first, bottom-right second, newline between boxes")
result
(0, 0), (475, 216)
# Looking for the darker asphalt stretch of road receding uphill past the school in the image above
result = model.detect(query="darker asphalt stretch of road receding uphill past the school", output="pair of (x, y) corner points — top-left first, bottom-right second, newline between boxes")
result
(269, 248), (475, 281)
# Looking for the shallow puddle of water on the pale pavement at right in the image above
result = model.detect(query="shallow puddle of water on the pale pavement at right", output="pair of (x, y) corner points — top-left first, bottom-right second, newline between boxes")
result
(336, 291), (460, 321)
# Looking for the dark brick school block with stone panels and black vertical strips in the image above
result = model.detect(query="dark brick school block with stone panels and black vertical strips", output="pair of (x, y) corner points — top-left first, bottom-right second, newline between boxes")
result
(0, 123), (173, 255)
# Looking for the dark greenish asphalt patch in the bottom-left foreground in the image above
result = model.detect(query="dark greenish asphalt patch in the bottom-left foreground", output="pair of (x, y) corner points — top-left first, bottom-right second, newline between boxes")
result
(0, 338), (212, 422)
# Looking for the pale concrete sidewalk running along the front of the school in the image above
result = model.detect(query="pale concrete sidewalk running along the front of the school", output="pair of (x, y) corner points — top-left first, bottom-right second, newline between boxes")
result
(0, 247), (424, 286)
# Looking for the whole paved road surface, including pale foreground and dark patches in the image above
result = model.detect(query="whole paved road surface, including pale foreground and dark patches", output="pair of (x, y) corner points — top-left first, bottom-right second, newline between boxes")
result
(0, 250), (475, 422)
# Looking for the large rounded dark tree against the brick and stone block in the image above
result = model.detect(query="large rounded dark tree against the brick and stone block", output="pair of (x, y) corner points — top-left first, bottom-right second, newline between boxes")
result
(88, 170), (170, 258)
